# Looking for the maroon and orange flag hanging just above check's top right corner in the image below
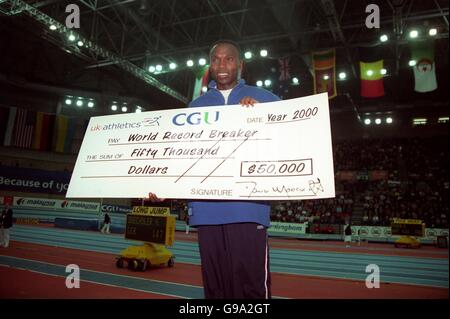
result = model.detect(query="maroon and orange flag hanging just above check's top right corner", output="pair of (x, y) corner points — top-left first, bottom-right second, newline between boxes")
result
(312, 49), (337, 99)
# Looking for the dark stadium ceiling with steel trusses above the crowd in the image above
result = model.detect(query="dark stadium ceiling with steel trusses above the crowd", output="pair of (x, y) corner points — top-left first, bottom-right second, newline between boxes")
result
(0, 0), (449, 119)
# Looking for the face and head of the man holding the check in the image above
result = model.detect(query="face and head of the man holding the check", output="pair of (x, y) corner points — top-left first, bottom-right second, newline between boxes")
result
(209, 43), (242, 90)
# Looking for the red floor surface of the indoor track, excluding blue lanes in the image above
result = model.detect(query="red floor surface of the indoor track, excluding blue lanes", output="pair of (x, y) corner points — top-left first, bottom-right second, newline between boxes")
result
(0, 240), (448, 299)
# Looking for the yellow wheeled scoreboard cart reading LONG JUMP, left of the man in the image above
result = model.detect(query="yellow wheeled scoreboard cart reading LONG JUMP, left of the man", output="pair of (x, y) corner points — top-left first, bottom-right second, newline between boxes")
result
(116, 206), (175, 271)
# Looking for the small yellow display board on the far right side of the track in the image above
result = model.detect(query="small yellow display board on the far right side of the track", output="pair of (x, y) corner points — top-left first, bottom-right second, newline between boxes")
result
(391, 218), (425, 248)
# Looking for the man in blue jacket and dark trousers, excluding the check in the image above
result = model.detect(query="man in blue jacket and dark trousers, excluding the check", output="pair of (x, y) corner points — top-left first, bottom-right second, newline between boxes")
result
(149, 41), (280, 299)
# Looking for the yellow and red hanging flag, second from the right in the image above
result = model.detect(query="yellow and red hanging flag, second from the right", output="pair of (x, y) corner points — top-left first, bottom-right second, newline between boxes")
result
(359, 47), (384, 98)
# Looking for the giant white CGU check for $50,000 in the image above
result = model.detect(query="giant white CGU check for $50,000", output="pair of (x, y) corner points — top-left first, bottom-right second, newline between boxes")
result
(67, 94), (335, 200)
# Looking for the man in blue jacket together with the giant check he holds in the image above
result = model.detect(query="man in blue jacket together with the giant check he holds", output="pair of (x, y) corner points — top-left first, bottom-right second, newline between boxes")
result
(67, 41), (335, 299)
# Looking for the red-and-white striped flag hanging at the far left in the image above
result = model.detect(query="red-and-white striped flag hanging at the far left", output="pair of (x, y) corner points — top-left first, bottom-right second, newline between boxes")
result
(12, 109), (36, 148)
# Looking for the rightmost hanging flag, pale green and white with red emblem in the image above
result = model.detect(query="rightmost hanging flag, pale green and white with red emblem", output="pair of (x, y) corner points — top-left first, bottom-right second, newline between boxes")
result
(411, 41), (437, 93)
